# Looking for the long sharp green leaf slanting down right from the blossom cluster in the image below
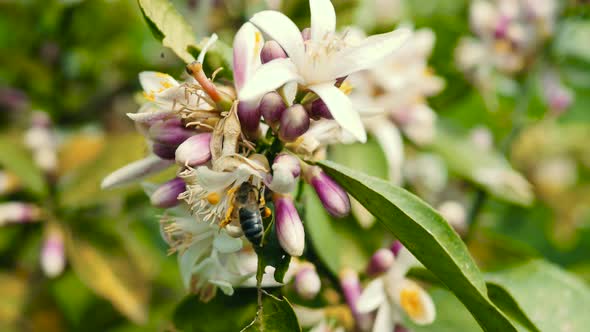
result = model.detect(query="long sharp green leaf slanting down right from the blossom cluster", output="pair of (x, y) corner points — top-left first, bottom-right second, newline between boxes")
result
(318, 161), (516, 331)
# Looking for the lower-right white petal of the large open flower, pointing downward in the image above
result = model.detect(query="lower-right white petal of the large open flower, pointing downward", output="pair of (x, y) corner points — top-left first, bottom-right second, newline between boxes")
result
(309, 83), (367, 143)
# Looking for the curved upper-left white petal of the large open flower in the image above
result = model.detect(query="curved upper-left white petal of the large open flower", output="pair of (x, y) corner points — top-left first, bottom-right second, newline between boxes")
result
(250, 10), (305, 63)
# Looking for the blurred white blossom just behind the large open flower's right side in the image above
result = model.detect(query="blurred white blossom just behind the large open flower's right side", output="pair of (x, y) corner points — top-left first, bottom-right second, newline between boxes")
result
(351, 29), (444, 183)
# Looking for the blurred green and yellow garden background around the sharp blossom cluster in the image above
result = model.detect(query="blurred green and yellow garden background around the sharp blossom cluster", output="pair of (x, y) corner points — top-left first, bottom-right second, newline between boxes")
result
(0, 0), (590, 332)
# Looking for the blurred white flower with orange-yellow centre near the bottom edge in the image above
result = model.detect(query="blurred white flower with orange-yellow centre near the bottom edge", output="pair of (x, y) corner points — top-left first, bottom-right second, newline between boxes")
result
(357, 248), (436, 332)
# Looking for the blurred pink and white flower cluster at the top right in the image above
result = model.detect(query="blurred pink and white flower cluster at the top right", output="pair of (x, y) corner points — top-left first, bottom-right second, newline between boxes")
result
(457, 0), (558, 84)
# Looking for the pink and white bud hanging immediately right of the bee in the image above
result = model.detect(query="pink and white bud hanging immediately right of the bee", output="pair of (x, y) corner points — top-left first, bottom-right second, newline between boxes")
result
(273, 194), (305, 257)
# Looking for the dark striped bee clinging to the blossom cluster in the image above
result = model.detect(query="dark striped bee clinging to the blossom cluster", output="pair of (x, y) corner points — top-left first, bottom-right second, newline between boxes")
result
(235, 182), (270, 246)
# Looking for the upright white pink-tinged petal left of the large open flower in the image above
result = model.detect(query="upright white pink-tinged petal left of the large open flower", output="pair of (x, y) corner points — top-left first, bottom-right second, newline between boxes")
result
(233, 22), (264, 94)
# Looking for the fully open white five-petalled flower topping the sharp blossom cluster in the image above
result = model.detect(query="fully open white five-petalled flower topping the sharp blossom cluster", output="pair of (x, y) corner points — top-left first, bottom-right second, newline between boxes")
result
(241, 0), (408, 141)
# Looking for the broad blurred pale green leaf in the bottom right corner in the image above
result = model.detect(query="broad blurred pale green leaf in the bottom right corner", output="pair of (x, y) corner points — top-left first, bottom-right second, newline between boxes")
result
(487, 260), (590, 332)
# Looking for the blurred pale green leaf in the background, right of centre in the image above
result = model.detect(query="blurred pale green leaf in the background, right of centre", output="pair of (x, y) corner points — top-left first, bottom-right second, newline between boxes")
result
(429, 127), (534, 206)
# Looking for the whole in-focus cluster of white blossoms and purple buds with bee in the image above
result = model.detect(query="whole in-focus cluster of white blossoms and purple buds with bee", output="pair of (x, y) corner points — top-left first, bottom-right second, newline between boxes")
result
(102, 0), (410, 300)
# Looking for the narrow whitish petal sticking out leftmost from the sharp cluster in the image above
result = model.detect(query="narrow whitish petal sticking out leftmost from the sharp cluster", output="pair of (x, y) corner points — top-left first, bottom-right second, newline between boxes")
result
(100, 155), (174, 189)
